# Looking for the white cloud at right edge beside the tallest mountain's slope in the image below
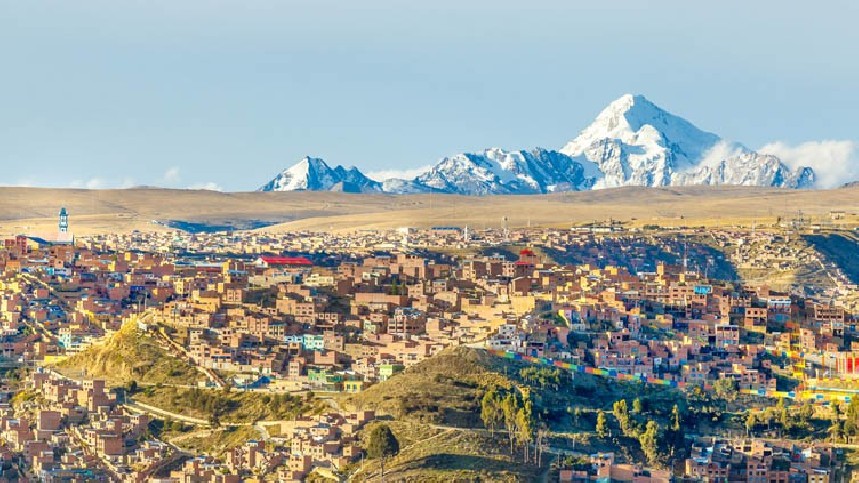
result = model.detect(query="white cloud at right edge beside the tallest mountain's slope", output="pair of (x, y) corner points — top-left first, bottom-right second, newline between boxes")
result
(758, 140), (859, 188)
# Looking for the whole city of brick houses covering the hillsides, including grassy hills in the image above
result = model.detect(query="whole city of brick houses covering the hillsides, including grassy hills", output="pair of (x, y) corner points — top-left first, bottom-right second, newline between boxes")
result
(0, 209), (859, 483)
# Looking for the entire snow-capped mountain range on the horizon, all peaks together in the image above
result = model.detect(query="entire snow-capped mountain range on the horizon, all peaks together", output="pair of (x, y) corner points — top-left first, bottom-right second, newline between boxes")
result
(261, 94), (815, 195)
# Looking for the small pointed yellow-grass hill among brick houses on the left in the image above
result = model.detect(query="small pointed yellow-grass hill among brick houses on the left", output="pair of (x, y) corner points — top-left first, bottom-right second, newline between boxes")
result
(56, 322), (205, 385)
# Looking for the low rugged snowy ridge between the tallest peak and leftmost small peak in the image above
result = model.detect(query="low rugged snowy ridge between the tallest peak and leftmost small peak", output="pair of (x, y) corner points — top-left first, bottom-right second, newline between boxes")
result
(415, 148), (595, 195)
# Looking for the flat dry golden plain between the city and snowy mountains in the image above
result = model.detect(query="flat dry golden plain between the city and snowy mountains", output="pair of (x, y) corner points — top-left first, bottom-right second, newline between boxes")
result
(0, 187), (859, 235)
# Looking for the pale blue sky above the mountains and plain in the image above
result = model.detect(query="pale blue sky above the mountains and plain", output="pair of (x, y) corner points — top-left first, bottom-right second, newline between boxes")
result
(0, 0), (859, 191)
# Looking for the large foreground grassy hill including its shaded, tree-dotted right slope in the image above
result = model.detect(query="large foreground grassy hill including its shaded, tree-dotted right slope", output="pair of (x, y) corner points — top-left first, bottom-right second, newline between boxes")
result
(341, 347), (700, 481)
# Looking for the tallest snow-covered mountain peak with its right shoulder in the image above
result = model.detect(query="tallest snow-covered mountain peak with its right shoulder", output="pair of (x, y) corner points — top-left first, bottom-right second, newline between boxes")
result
(561, 94), (813, 188)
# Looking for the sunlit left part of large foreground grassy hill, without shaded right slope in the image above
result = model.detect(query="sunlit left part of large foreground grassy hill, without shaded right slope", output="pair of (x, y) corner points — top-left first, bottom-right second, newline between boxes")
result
(341, 347), (538, 482)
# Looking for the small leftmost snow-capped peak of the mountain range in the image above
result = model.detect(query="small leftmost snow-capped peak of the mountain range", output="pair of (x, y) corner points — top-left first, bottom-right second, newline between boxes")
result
(259, 156), (382, 193)
